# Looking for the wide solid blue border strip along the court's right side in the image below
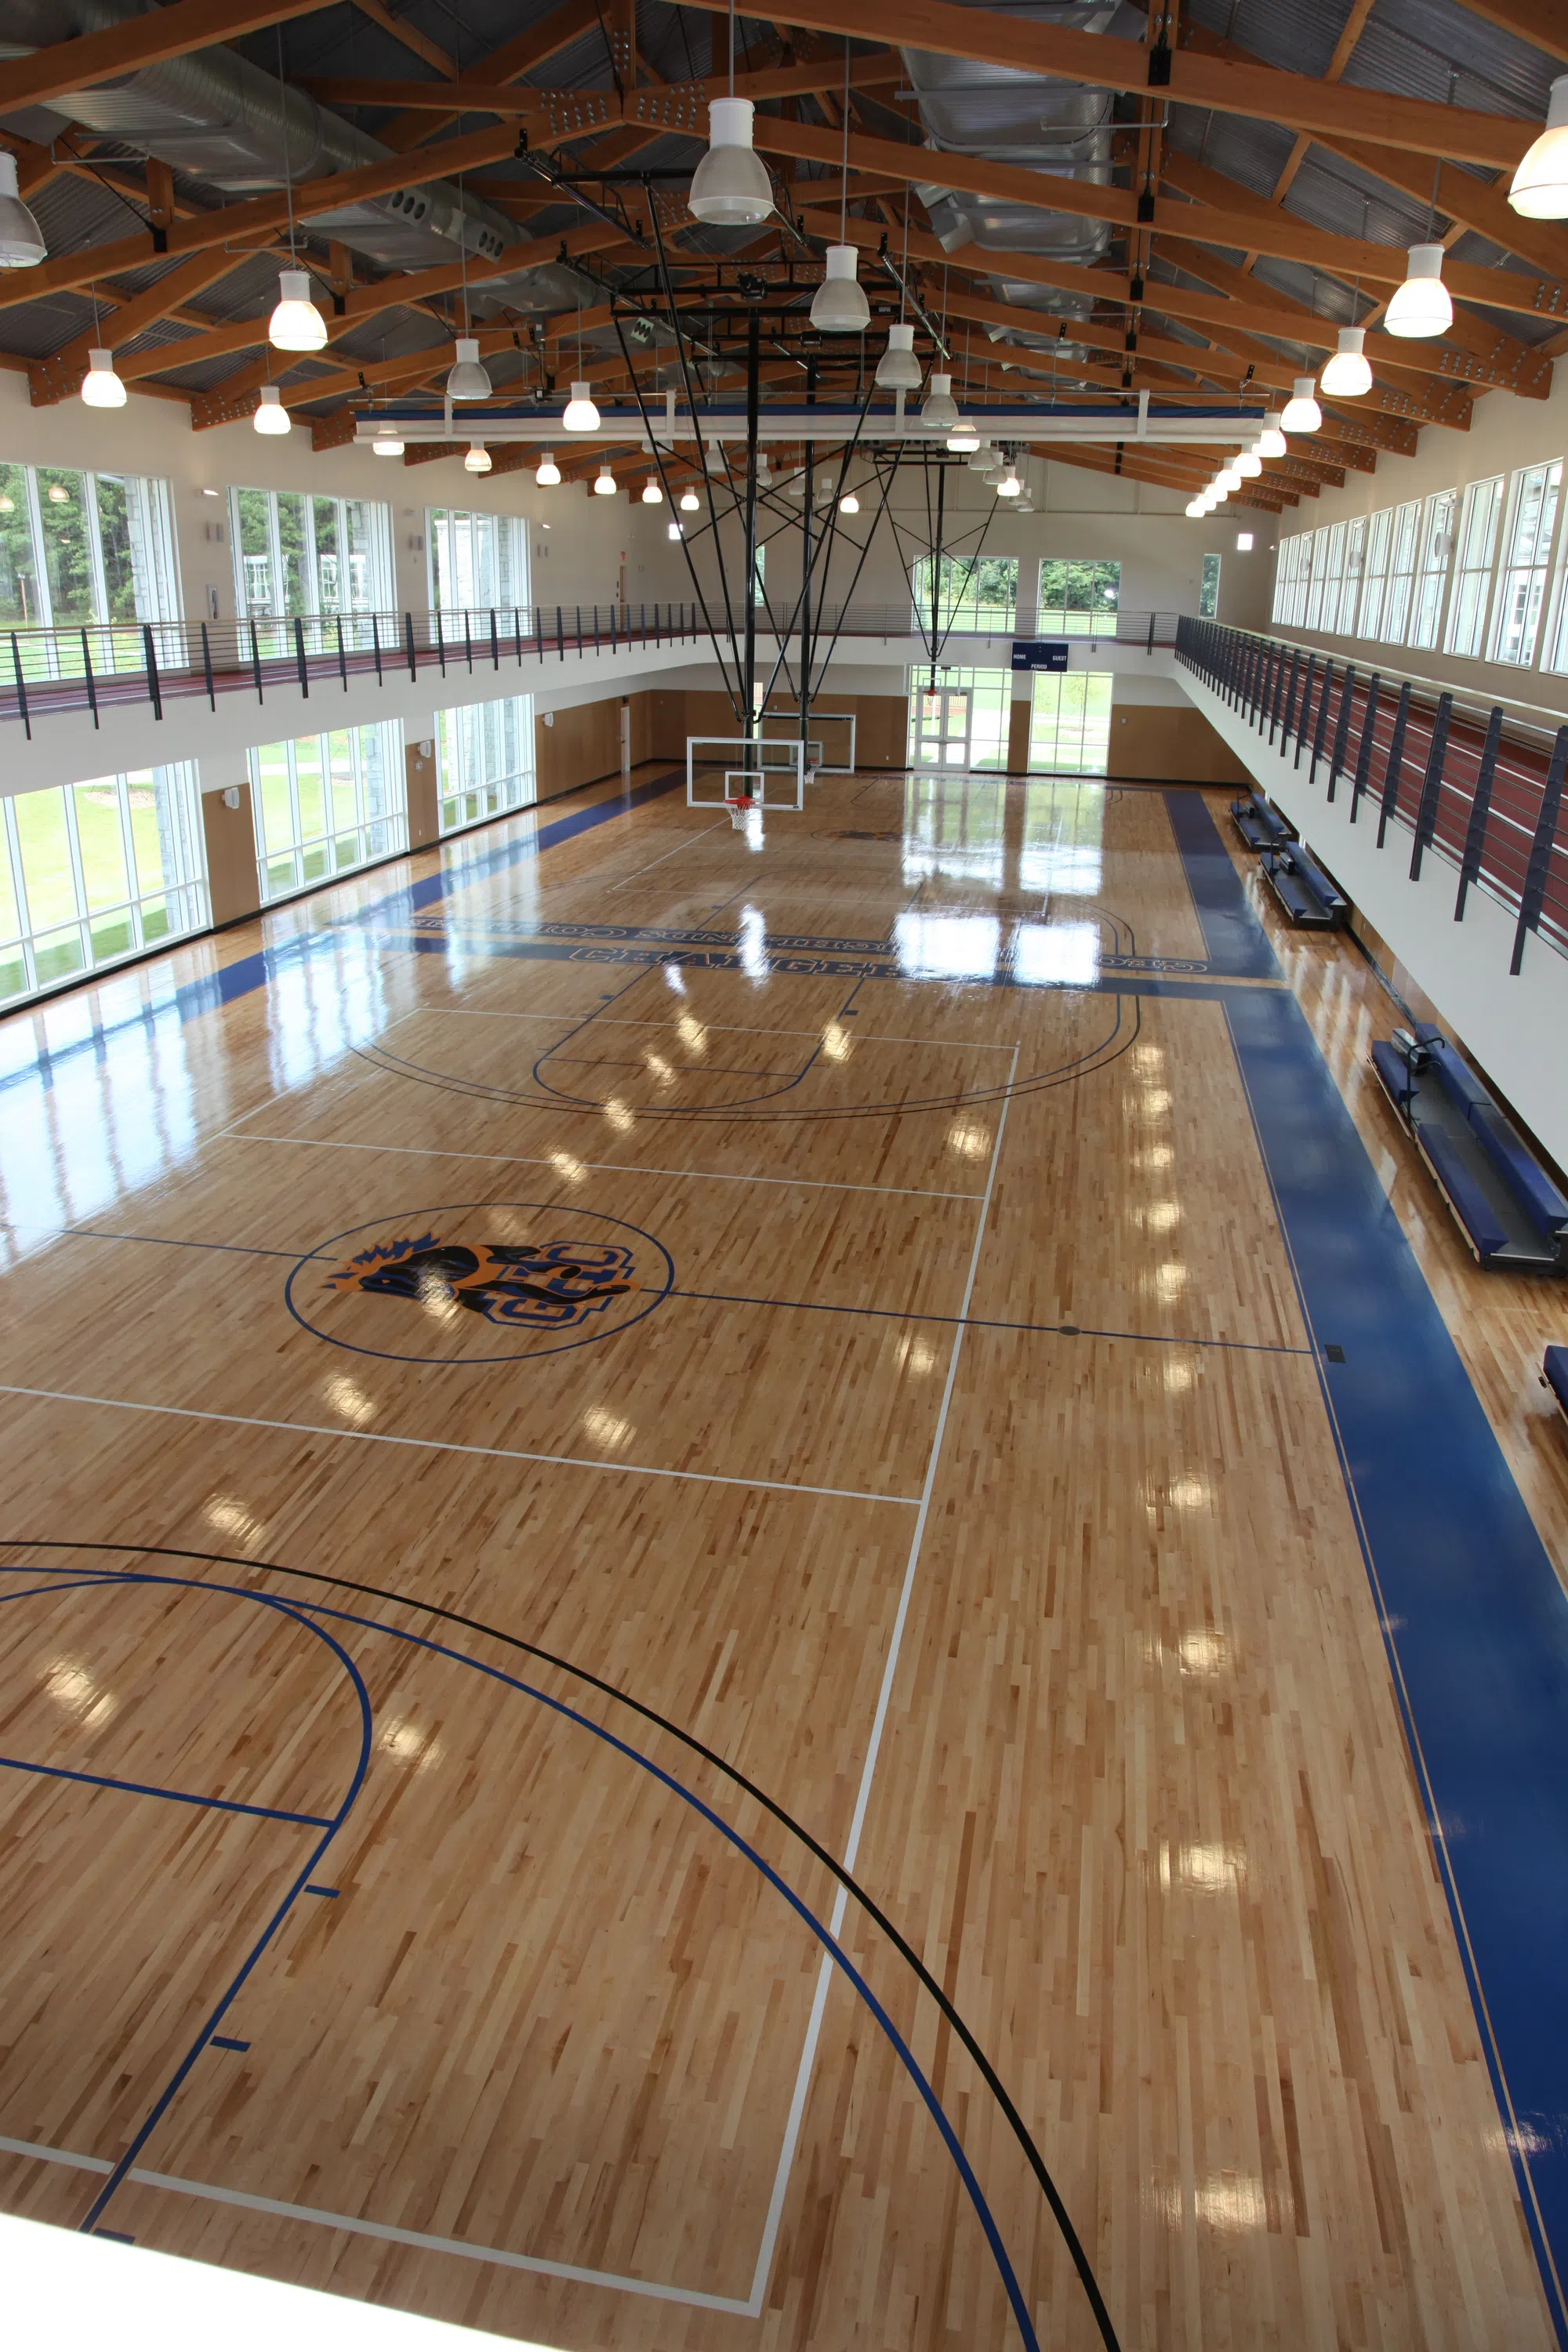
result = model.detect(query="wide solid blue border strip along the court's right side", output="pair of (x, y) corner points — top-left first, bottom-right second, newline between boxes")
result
(1166, 795), (1568, 2345)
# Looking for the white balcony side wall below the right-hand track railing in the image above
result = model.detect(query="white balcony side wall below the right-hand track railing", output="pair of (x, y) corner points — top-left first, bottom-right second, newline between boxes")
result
(1180, 670), (1568, 1164)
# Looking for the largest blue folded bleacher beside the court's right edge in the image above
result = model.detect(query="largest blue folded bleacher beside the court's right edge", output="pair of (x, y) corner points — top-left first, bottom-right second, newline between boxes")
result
(1370, 1023), (1568, 1275)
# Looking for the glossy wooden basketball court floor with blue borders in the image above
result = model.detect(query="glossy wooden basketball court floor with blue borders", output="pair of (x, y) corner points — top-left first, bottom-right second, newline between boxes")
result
(0, 776), (1568, 2352)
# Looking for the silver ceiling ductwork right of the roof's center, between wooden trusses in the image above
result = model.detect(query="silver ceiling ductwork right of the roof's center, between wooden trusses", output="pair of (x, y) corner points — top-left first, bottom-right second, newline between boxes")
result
(900, 0), (1147, 341)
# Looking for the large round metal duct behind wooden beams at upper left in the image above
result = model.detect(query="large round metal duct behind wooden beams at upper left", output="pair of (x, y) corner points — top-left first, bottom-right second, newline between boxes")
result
(0, 0), (576, 310)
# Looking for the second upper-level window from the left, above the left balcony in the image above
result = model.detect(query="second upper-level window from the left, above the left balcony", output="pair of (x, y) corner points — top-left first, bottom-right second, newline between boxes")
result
(228, 489), (393, 642)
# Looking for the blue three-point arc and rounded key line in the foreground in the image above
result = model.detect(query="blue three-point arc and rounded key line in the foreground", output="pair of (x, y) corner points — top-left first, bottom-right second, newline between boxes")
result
(0, 1564), (1039, 2352)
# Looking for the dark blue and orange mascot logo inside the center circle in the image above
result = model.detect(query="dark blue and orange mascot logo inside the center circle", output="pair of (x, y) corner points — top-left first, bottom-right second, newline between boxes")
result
(327, 1232), (640, 1331)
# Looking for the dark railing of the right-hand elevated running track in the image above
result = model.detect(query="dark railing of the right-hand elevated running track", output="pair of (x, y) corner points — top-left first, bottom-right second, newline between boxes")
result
(1175, 619), (1568, 971)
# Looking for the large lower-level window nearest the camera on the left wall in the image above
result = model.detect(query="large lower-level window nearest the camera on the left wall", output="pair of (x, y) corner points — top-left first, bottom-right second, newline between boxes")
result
(0, 764), (209, 1002)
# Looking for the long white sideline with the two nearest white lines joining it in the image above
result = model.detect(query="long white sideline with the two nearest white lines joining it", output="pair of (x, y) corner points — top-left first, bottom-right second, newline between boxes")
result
(0, 1068), (1020, 2319)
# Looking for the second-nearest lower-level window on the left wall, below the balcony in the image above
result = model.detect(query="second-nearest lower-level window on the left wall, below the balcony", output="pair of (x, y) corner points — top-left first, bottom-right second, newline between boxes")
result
(247, 722), (409, 901)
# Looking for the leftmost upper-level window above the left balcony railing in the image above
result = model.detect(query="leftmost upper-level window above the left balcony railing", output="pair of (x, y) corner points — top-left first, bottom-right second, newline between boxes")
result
(0, 466), (181, 680)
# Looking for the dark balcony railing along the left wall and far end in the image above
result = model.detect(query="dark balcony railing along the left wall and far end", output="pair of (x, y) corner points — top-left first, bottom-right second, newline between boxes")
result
(0, 602), (1178, 739)
